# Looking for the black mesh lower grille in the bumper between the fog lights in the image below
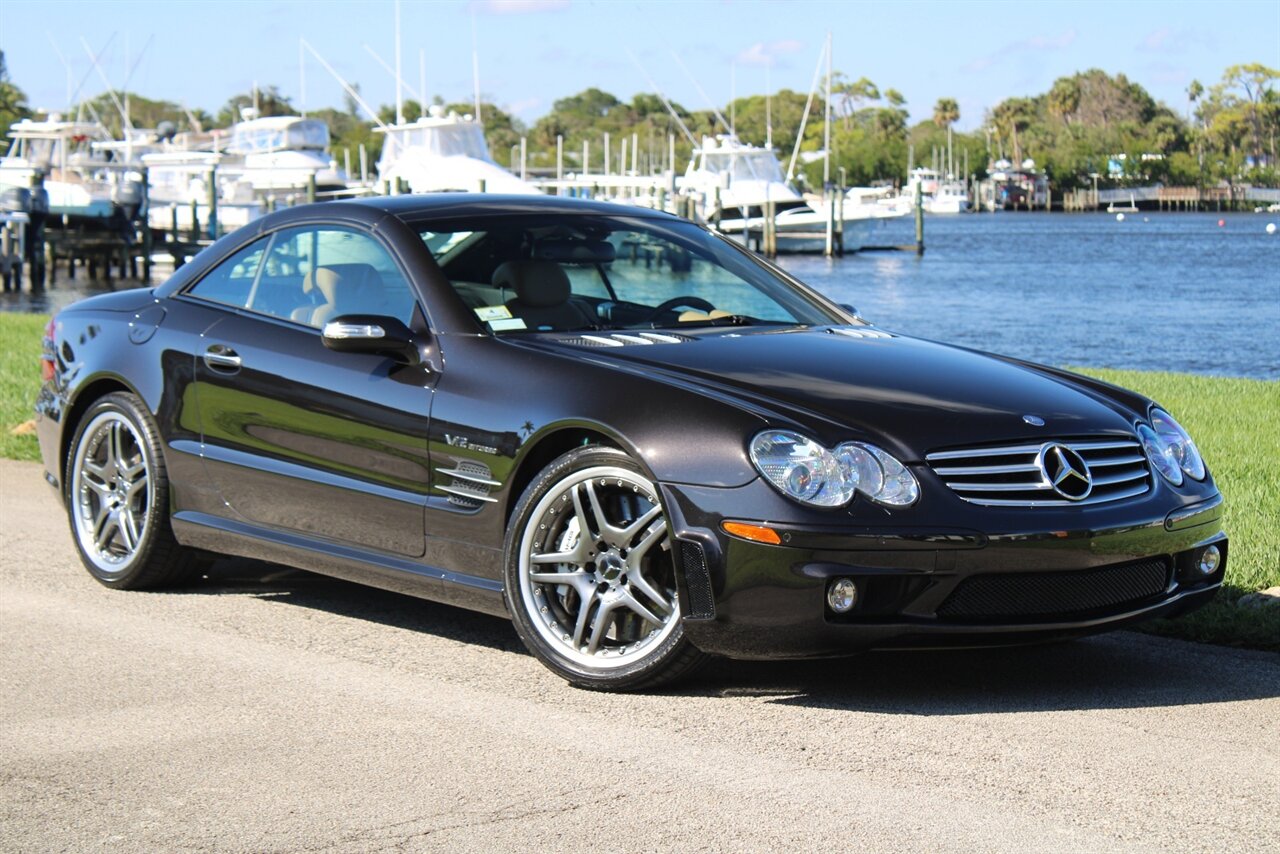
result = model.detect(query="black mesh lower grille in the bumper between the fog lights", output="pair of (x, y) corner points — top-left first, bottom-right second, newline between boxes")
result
(938, 558), (1169, 620)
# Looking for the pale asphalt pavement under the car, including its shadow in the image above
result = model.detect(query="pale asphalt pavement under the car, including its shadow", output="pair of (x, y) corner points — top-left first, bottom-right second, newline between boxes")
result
(0, 462), (1280, 851)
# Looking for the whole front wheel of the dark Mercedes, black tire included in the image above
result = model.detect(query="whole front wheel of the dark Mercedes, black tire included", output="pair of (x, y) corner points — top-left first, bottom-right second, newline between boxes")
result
(503, 446), (709, 691)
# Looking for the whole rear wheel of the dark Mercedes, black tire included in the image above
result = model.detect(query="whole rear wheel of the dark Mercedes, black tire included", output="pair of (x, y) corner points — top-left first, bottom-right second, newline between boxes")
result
(63, 392), (209, 590)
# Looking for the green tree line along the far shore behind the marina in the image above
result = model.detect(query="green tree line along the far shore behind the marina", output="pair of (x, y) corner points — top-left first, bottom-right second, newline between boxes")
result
(0, 51), (1280, 197)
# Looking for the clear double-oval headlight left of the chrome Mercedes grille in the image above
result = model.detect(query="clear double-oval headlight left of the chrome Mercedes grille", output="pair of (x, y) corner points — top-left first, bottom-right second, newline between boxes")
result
(750, 430), (920, 507)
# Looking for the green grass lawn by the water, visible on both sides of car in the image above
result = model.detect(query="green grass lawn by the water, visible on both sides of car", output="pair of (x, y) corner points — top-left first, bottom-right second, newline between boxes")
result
(0, 312), (1280, 652)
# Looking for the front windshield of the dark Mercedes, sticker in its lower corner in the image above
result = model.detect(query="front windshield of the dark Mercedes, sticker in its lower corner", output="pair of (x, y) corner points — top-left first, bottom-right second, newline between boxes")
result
(407, 214), (841, 334)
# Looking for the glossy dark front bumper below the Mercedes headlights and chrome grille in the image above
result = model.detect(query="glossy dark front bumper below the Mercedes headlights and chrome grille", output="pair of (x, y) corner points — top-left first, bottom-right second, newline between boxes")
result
(663, 481), (1228, 658)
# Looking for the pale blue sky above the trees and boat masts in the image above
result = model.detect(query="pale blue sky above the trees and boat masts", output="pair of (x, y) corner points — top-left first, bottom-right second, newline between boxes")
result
(0, 0), (1280, 128)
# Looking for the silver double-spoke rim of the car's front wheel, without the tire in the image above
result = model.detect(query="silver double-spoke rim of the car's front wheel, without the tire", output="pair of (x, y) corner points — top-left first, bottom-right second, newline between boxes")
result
(520, 466), (678, 668)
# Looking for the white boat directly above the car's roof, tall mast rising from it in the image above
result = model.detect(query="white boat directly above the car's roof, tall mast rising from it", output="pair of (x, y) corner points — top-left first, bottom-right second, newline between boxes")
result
(374, 106), (540, 195)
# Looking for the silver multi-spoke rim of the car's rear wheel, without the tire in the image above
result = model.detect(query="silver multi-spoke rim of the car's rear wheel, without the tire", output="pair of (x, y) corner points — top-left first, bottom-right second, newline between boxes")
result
(69, 411), (155, 575)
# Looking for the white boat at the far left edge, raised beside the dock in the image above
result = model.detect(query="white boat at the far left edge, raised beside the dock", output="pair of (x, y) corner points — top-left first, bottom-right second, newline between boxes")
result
(0, 113), (142, 225)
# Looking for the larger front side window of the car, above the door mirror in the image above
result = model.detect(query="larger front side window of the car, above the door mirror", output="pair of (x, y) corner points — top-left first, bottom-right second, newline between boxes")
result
(240, 225), (416, 329)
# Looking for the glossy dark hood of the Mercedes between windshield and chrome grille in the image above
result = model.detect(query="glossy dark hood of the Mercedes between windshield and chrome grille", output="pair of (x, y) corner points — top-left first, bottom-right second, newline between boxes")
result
(540, 326), (1135, 460)
